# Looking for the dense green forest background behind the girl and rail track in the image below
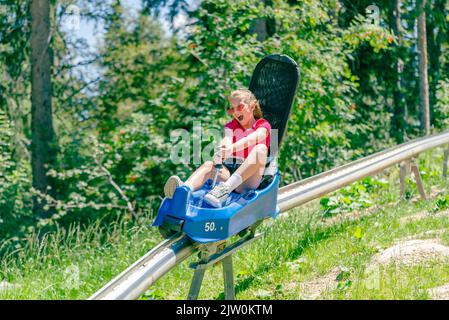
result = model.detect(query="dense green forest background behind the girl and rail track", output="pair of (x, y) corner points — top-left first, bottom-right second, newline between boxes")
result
(0, 0), (449, 252)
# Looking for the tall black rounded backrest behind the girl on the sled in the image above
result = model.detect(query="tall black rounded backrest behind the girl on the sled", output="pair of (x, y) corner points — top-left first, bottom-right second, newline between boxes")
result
(249, 54), (299, 157)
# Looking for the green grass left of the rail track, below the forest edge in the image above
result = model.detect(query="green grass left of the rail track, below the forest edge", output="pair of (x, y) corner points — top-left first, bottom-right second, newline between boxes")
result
(0, 218), (160, 299)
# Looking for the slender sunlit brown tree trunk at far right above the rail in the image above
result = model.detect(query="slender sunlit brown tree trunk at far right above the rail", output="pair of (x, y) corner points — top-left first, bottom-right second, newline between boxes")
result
(418, 0), (430, 135)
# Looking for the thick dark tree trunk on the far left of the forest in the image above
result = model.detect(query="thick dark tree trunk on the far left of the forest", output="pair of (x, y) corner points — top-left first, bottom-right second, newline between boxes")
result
(30, 0), (56, 217)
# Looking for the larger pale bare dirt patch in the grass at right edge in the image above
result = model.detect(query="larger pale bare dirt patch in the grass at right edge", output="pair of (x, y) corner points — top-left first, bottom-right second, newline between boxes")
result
(372, 239), (449, 265)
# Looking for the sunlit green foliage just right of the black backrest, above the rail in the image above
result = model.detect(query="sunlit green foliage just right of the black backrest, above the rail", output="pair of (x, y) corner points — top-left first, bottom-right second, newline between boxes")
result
(267, 1), (391, 182)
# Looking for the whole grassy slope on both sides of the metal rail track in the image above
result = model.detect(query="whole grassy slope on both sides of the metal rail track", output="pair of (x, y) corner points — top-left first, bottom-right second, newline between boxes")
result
(0, 148), (449, 299)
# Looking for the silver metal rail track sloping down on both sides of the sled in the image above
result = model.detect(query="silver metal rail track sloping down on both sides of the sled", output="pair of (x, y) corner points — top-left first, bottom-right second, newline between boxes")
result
(89, 131), (449, 300)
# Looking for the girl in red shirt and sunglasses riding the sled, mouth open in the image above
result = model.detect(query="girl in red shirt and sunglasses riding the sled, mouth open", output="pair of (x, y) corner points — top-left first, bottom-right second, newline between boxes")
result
(164, 89), (271, 207)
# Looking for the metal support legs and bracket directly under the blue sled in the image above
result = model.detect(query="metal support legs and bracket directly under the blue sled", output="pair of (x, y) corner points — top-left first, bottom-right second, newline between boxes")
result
(187, 233), (262, 300)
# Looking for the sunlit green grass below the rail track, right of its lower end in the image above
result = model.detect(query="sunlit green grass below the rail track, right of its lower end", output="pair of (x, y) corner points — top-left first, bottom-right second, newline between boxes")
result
(148, 201), (449, 299)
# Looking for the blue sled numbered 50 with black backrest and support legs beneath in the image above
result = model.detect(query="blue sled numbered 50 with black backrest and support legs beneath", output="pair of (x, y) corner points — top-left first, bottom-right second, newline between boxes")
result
(153, 54), (299, 299)
